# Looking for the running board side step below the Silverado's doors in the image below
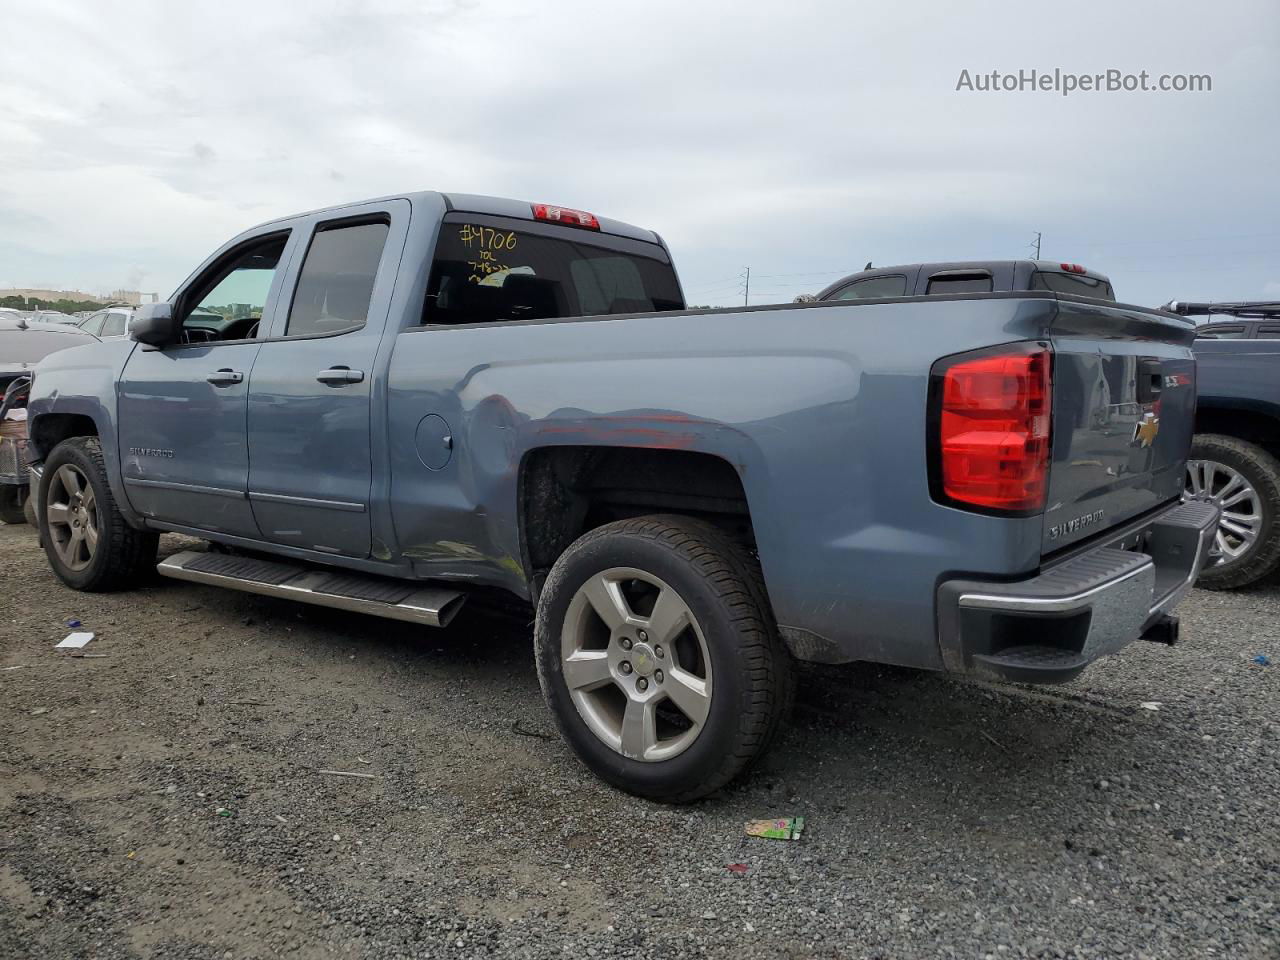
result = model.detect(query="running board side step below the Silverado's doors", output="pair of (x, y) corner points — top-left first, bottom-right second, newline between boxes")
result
(156, 550), (467, 627)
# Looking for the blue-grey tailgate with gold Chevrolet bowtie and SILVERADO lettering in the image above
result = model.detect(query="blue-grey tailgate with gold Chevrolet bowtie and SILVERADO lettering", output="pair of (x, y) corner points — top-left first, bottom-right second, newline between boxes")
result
(1042, 297), (1196, 554)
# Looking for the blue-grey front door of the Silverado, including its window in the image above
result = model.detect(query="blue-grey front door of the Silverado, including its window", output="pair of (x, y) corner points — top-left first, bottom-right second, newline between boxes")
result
(119, 230), (289, 539)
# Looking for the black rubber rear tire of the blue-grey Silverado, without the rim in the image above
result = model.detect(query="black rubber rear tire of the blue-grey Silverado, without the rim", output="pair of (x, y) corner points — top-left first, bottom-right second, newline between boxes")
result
(534, 516), (795, 803)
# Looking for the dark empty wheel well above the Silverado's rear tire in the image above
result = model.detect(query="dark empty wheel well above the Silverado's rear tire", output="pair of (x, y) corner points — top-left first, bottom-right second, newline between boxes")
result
(520, 447), (755, 598)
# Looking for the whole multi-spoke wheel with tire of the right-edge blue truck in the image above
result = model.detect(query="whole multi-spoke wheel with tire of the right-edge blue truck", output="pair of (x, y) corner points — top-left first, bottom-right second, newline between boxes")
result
(1185, 434), (1280, 590)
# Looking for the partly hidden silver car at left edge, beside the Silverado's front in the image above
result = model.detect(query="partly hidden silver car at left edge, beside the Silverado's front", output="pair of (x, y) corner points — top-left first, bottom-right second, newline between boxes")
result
(0, 311), (93, 524)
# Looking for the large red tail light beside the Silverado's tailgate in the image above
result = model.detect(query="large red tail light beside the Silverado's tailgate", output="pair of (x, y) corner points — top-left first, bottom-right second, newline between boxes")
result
(933, 343), (1052, 513)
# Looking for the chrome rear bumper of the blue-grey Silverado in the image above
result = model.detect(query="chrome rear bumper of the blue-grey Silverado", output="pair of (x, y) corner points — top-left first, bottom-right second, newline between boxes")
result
(937, 503), (1217, 684)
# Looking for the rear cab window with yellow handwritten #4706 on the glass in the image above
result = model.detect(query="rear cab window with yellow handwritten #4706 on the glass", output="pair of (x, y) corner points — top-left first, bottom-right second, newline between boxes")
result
(422, 212), (685, 324)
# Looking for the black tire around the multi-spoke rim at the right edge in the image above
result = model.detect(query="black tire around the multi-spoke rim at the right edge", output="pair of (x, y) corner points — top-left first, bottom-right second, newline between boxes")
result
(1190, 434), (1280, 590)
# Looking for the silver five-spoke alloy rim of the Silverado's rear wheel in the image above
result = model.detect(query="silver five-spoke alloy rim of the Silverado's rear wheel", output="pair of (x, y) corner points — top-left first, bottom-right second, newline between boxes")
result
(561, 567), (712, 762)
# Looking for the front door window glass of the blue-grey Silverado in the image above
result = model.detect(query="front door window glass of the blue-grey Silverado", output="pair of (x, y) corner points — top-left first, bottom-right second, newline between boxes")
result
(182, 234), (288, 343)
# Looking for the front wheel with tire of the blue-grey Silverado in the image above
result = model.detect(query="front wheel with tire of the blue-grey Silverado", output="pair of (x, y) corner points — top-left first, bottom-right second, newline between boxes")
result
(40, 436), (159, 590)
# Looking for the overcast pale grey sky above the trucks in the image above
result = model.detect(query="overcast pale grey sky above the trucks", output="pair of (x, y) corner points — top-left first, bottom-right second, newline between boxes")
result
(0, 0), (1280, 305)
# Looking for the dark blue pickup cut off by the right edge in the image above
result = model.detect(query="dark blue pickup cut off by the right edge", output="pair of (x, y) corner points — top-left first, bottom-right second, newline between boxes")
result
(1166, 301), (1280, 590)
